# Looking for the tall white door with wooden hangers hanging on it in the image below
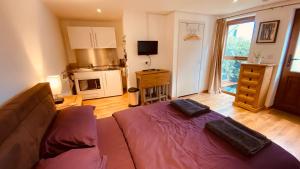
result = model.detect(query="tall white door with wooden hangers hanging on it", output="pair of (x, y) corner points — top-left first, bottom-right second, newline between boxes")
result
(177, 22), (204, 97)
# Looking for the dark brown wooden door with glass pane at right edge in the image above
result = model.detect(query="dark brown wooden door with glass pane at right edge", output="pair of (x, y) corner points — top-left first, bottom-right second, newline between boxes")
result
(275, 9), (300, 115)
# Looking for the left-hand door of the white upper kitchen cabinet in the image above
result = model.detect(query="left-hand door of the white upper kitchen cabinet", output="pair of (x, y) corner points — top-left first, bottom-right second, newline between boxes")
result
(68, 26), (94, 49)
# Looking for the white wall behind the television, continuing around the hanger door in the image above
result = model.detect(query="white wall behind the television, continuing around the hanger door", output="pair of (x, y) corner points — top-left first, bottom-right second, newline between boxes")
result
(123, 11), (216, 97)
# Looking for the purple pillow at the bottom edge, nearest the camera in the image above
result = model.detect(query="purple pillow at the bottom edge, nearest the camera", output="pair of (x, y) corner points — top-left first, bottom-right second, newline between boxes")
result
(35, 147), (107, 169)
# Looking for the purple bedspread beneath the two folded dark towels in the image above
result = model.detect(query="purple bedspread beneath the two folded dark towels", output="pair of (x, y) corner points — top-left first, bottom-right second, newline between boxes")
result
(113, 102), (300, 169)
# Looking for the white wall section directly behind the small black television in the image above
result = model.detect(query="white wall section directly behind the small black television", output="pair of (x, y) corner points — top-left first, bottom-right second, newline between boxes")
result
(123, 11), (172, 87)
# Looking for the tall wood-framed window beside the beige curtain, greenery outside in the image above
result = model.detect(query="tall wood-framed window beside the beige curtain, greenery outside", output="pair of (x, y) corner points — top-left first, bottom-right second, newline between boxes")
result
(222, 17), (255, 94)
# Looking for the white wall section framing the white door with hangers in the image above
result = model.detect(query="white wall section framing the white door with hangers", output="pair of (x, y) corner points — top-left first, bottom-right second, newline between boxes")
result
(172, 12), (216, 97)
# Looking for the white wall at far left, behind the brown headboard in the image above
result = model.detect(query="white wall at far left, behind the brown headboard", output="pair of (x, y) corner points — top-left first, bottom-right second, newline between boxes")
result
(0, 0), (66, 105)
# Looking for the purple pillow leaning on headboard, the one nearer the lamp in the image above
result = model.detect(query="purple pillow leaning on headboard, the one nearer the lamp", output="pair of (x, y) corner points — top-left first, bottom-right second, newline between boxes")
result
(41, 106), (97, 158)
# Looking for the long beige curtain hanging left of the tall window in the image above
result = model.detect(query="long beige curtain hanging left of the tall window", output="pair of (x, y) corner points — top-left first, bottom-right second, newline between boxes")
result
(208, 19), (226, 94)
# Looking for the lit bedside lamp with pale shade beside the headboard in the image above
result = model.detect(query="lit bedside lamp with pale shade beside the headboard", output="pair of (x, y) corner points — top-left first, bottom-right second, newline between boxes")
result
(47, 75), (64, 104)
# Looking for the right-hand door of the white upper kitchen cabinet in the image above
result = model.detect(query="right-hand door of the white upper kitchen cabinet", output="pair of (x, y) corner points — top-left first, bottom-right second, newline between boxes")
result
(93, 27), (117, 48)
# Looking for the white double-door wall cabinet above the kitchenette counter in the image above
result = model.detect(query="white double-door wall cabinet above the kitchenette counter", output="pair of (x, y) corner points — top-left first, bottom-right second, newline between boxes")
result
(68, 26), (117, 49)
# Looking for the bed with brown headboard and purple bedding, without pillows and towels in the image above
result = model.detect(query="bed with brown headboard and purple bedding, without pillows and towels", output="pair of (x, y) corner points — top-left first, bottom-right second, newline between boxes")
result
(0, 84), (300, 169)
